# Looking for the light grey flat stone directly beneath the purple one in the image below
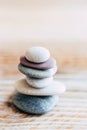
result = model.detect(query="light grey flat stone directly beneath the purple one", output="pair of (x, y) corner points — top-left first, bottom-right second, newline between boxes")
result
(18, 64), (57, 78)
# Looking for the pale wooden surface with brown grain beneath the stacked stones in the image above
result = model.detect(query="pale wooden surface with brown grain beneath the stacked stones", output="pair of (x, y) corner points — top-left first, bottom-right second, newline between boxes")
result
(0, 51), (87, 130)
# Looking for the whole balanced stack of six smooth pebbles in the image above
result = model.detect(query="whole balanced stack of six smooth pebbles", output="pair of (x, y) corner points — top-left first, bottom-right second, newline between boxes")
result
(13, 47), (65, 114)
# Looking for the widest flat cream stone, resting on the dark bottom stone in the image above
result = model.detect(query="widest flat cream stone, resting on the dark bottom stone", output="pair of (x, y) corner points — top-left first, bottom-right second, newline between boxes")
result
(15, 78), (65, 96)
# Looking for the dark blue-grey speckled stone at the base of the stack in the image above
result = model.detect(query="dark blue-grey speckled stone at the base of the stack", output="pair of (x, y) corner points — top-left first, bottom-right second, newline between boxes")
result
(12, 92), (58, 114)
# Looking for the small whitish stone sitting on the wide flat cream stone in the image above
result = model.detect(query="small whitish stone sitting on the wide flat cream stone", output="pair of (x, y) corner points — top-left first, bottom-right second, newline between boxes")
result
(26, 77), (53, 88)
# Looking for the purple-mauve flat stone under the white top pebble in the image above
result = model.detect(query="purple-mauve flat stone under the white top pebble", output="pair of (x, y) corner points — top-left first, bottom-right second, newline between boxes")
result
(20, 56), (56, 70)
